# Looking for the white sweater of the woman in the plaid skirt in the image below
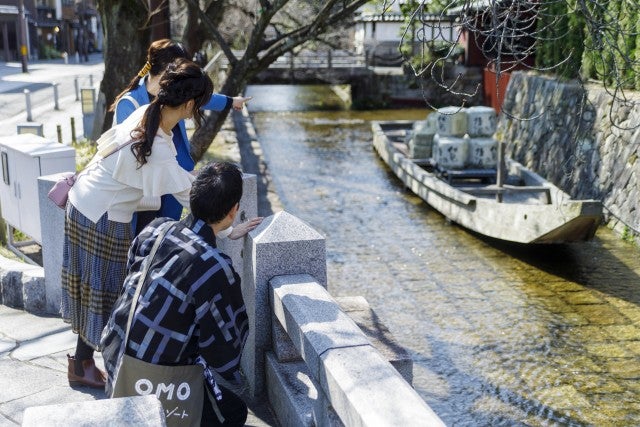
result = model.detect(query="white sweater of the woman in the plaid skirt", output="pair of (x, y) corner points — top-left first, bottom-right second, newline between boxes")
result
(69, 105), (195, 223)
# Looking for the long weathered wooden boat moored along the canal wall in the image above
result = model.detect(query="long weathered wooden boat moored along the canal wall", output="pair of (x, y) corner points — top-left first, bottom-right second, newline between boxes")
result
(371, 121), (602, 243)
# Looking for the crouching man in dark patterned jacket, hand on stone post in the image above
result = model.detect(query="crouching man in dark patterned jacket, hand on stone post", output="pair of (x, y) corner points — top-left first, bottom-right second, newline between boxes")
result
(102, 163), (262, 425)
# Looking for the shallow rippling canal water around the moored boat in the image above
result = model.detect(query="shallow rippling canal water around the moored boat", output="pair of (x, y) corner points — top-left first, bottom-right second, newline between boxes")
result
(247, 86), (640, 426)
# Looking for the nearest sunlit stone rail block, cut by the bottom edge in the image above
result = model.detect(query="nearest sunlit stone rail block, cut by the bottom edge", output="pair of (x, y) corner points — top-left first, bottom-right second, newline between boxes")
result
(319, 346), (445, 427)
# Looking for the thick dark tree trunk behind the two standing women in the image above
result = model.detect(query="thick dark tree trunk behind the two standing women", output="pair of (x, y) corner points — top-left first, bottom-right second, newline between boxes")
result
(98, 0), (151, 132)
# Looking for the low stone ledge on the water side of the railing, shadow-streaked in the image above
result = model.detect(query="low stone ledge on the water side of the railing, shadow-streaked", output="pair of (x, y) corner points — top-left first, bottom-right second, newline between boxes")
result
(336, 296), (413, 384)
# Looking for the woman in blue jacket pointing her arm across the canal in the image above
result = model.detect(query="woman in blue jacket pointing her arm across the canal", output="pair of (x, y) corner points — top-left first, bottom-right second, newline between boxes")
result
(109, 39), (251, 234)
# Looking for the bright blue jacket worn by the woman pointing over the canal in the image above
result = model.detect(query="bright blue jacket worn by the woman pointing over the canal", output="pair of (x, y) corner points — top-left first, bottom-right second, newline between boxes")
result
(115, 77), (233, 222)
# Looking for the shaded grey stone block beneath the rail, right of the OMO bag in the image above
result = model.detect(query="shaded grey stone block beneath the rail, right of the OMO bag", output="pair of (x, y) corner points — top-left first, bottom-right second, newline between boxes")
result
(265, 352), (318, 427)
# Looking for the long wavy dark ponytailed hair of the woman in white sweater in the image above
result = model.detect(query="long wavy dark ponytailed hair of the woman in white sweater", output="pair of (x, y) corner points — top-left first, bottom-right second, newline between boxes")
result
(131, 59), (213, 166)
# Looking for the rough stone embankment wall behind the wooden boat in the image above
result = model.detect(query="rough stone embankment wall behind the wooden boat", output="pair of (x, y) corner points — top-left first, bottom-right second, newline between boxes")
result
(496, 72), (640, 244)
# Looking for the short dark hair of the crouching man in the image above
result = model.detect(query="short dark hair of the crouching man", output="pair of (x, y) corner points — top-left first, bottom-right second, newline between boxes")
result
(190, 162), (242, 224)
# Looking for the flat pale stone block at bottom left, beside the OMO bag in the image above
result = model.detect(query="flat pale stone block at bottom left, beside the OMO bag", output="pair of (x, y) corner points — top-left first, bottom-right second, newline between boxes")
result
(22, 395), (166, 427)
